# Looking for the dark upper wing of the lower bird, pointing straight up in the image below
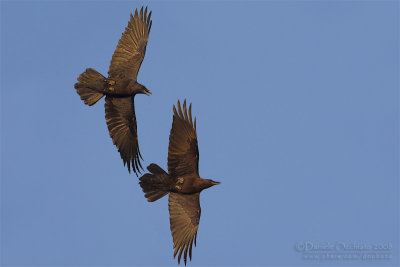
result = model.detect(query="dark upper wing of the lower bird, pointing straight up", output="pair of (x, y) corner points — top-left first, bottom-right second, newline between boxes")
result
(168, 100), (199, 178)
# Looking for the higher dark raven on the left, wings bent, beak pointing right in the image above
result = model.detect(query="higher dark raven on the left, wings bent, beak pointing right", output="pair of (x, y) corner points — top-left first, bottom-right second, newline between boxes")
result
(75, 7), (152, 175)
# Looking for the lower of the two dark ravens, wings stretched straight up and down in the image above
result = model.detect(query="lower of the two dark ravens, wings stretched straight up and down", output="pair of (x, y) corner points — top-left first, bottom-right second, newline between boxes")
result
(140, 100), (219, 265)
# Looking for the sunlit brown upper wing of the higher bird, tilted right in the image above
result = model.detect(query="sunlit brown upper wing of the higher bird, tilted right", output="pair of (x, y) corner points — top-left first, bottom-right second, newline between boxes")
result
(108, 7), (152, 80)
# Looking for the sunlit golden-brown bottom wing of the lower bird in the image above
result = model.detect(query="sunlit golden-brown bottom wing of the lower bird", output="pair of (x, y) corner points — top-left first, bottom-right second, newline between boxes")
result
(168, 192), (201, 265)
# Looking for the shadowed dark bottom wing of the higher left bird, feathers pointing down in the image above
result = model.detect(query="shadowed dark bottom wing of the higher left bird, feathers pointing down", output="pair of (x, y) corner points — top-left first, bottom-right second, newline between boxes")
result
(105, 96), (143, 174)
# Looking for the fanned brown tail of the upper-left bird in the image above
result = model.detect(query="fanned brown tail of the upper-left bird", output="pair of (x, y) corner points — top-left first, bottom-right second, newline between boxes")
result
(74, 68), (106, 106)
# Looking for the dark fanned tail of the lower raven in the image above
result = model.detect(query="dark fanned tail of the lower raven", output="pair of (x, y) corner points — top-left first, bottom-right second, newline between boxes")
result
(139, 163), (172, 202)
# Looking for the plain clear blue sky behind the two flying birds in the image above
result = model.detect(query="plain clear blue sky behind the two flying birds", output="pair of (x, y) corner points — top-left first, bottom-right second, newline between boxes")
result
(1, 1), (400, 266)
